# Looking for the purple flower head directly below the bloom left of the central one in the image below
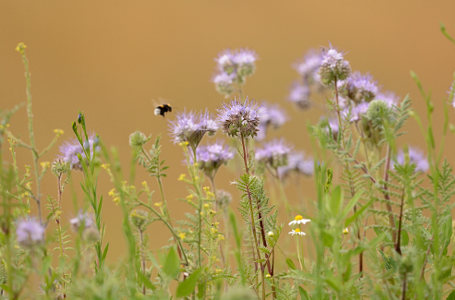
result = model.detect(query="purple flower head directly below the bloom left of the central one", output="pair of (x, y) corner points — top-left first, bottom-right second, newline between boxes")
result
(196, 143), (234, 178)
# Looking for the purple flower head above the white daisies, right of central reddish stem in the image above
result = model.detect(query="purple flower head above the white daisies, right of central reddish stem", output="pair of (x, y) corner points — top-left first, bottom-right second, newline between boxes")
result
(255, 140), (291, 169)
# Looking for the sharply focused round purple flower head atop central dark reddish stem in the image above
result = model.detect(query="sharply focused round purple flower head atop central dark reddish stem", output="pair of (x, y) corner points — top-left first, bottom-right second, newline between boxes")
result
(218, 99), (260, 138)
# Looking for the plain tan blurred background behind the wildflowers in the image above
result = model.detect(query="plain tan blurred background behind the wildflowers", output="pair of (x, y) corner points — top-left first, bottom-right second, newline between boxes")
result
(0, 0), (455, 259)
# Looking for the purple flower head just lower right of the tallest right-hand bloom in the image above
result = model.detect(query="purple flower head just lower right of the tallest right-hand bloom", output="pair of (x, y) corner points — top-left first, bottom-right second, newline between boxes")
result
(344, 72), (379, 103)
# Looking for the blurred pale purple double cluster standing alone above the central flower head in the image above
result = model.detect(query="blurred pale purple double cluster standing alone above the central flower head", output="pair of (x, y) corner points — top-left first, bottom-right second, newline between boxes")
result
(213, 49), (257, 97)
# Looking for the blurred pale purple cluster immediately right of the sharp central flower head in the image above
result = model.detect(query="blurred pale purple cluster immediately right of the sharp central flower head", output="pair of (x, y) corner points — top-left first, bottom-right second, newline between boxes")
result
(256, 103), (287, 140)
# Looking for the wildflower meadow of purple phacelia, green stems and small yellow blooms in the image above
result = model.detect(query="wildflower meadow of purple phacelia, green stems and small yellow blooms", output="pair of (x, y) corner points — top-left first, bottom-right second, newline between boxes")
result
(0, 27), (455, 300)
